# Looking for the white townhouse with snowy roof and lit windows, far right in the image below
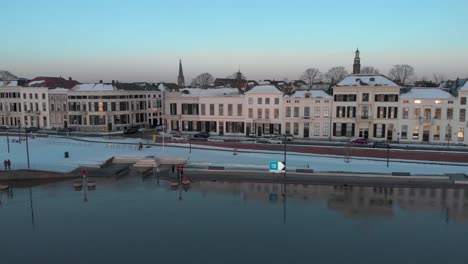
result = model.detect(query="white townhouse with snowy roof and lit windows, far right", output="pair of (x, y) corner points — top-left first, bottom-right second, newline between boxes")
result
(397, 87), (458, 144)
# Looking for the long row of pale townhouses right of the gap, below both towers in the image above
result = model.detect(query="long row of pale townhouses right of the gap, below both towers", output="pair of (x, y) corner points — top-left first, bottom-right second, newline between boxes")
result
(164, 75), (468, 144)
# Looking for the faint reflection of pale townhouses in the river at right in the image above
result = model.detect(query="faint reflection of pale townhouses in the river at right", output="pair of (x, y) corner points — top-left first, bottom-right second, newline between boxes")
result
(191, 181), (468, 222)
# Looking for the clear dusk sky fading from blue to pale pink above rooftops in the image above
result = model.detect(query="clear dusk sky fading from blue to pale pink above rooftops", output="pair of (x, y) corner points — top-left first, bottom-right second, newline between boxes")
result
(0, 0), (468, 82)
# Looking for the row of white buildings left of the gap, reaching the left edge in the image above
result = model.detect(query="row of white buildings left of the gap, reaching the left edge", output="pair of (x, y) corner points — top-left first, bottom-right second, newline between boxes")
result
(0, 80), (163, 132)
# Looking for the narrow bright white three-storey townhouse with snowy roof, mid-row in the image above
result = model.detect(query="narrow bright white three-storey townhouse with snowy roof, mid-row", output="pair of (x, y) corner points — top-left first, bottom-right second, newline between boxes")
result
(244, 85), (286, 136)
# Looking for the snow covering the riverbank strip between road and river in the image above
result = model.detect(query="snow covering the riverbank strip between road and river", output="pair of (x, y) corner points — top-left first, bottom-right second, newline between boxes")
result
(0, 137), (468, 175)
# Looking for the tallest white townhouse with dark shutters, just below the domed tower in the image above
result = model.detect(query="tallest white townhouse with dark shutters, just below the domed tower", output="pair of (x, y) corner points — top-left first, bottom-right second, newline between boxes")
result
(332, 74), (400, 140)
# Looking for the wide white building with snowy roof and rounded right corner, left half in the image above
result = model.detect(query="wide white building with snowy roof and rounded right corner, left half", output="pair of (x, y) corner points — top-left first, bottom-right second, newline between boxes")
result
(67, 83), (162, 132)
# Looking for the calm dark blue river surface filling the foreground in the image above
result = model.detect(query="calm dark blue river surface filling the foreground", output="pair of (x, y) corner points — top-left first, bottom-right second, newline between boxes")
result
(0, 177), (468, 264)
